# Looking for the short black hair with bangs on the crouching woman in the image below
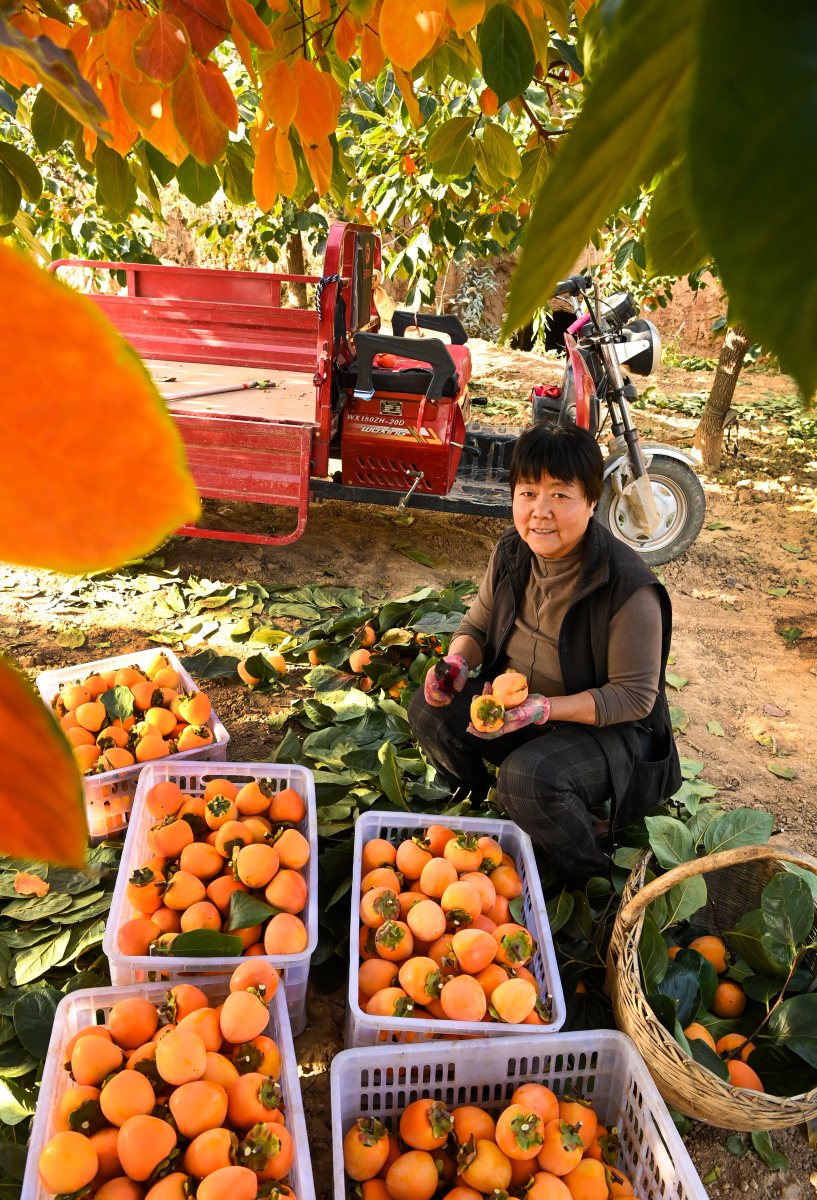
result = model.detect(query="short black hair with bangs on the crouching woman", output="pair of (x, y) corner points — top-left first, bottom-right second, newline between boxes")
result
(510, 421), (605, 504)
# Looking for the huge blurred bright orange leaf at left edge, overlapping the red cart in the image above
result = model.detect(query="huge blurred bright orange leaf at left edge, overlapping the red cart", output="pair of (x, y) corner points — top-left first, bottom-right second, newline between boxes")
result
(0, 242), (199, 571)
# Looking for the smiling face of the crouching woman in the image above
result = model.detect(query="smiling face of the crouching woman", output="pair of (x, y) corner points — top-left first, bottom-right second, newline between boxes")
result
(513, 474), (596, 558)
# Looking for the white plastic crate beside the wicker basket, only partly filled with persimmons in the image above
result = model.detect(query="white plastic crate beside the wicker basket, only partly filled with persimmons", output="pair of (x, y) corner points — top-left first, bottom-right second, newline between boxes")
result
(331, 1026), (707, 1200)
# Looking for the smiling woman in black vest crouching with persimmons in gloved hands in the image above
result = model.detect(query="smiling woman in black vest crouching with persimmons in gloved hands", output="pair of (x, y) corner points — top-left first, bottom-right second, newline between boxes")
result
(409, 426), (681, 886)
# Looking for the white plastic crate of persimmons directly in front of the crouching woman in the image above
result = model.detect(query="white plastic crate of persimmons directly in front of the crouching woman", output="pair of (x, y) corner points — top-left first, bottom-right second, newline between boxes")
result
(346, 812), (567, 1046)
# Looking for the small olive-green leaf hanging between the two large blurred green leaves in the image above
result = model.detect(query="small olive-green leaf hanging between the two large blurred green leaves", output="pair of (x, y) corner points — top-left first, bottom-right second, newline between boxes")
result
(644, 158), (705, 277)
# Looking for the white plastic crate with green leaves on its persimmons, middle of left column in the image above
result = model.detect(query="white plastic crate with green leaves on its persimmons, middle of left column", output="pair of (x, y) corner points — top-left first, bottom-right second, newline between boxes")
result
(102, 757), (318, 1036)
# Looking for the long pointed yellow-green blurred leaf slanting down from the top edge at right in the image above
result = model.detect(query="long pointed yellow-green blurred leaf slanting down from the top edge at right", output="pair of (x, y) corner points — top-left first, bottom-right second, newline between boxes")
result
(501, 0), (691, 334)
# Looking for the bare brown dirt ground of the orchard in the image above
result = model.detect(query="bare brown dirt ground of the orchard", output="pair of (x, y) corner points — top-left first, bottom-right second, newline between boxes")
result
(0, 342), (817, 1200)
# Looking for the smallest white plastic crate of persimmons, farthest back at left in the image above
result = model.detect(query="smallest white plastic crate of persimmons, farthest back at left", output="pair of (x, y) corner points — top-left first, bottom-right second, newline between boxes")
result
(37, 646), (230, 845)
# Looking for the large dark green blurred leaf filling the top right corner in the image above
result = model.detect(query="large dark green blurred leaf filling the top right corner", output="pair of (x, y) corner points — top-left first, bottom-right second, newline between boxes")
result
(689, 0), (817, 398)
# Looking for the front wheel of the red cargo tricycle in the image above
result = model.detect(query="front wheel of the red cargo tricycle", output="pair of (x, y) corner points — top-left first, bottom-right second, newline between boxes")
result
(596, 454), (707, 566)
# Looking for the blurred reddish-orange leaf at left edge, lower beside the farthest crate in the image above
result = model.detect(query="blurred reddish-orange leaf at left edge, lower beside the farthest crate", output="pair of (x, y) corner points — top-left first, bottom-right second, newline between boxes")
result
(0, 657), (88, 864)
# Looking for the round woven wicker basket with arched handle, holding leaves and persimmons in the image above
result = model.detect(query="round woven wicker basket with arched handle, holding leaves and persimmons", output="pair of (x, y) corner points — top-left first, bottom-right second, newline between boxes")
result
(607, 846), (817, 1130)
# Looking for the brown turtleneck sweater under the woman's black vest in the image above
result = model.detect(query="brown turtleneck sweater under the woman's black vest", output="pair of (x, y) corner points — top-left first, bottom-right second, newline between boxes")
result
(455, 545), (661, 725)
